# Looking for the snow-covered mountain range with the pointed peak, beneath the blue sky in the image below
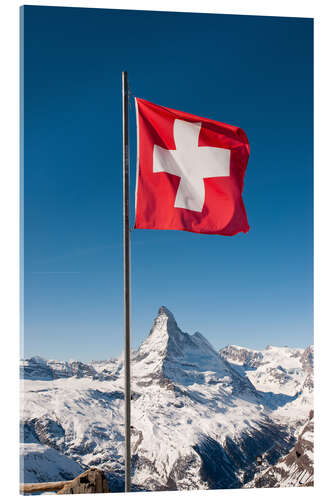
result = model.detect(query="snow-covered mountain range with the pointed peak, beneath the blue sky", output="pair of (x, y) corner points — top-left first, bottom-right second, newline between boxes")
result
(21, 307), (313, 491)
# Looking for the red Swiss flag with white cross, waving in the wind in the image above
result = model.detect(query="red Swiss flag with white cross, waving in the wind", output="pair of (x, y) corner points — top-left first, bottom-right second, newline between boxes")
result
(135, 98), (250, 236)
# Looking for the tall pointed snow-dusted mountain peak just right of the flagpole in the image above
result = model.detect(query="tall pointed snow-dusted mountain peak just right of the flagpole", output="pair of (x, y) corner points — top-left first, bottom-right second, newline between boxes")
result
(132, 306), (254, 392)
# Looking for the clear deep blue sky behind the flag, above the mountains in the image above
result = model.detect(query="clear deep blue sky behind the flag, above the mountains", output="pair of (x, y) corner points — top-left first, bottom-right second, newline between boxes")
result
(23, 7), (313, 360)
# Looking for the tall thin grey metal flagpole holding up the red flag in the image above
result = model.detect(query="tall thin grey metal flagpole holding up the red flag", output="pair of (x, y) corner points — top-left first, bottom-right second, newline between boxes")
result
(122, 71), (131, 492)
